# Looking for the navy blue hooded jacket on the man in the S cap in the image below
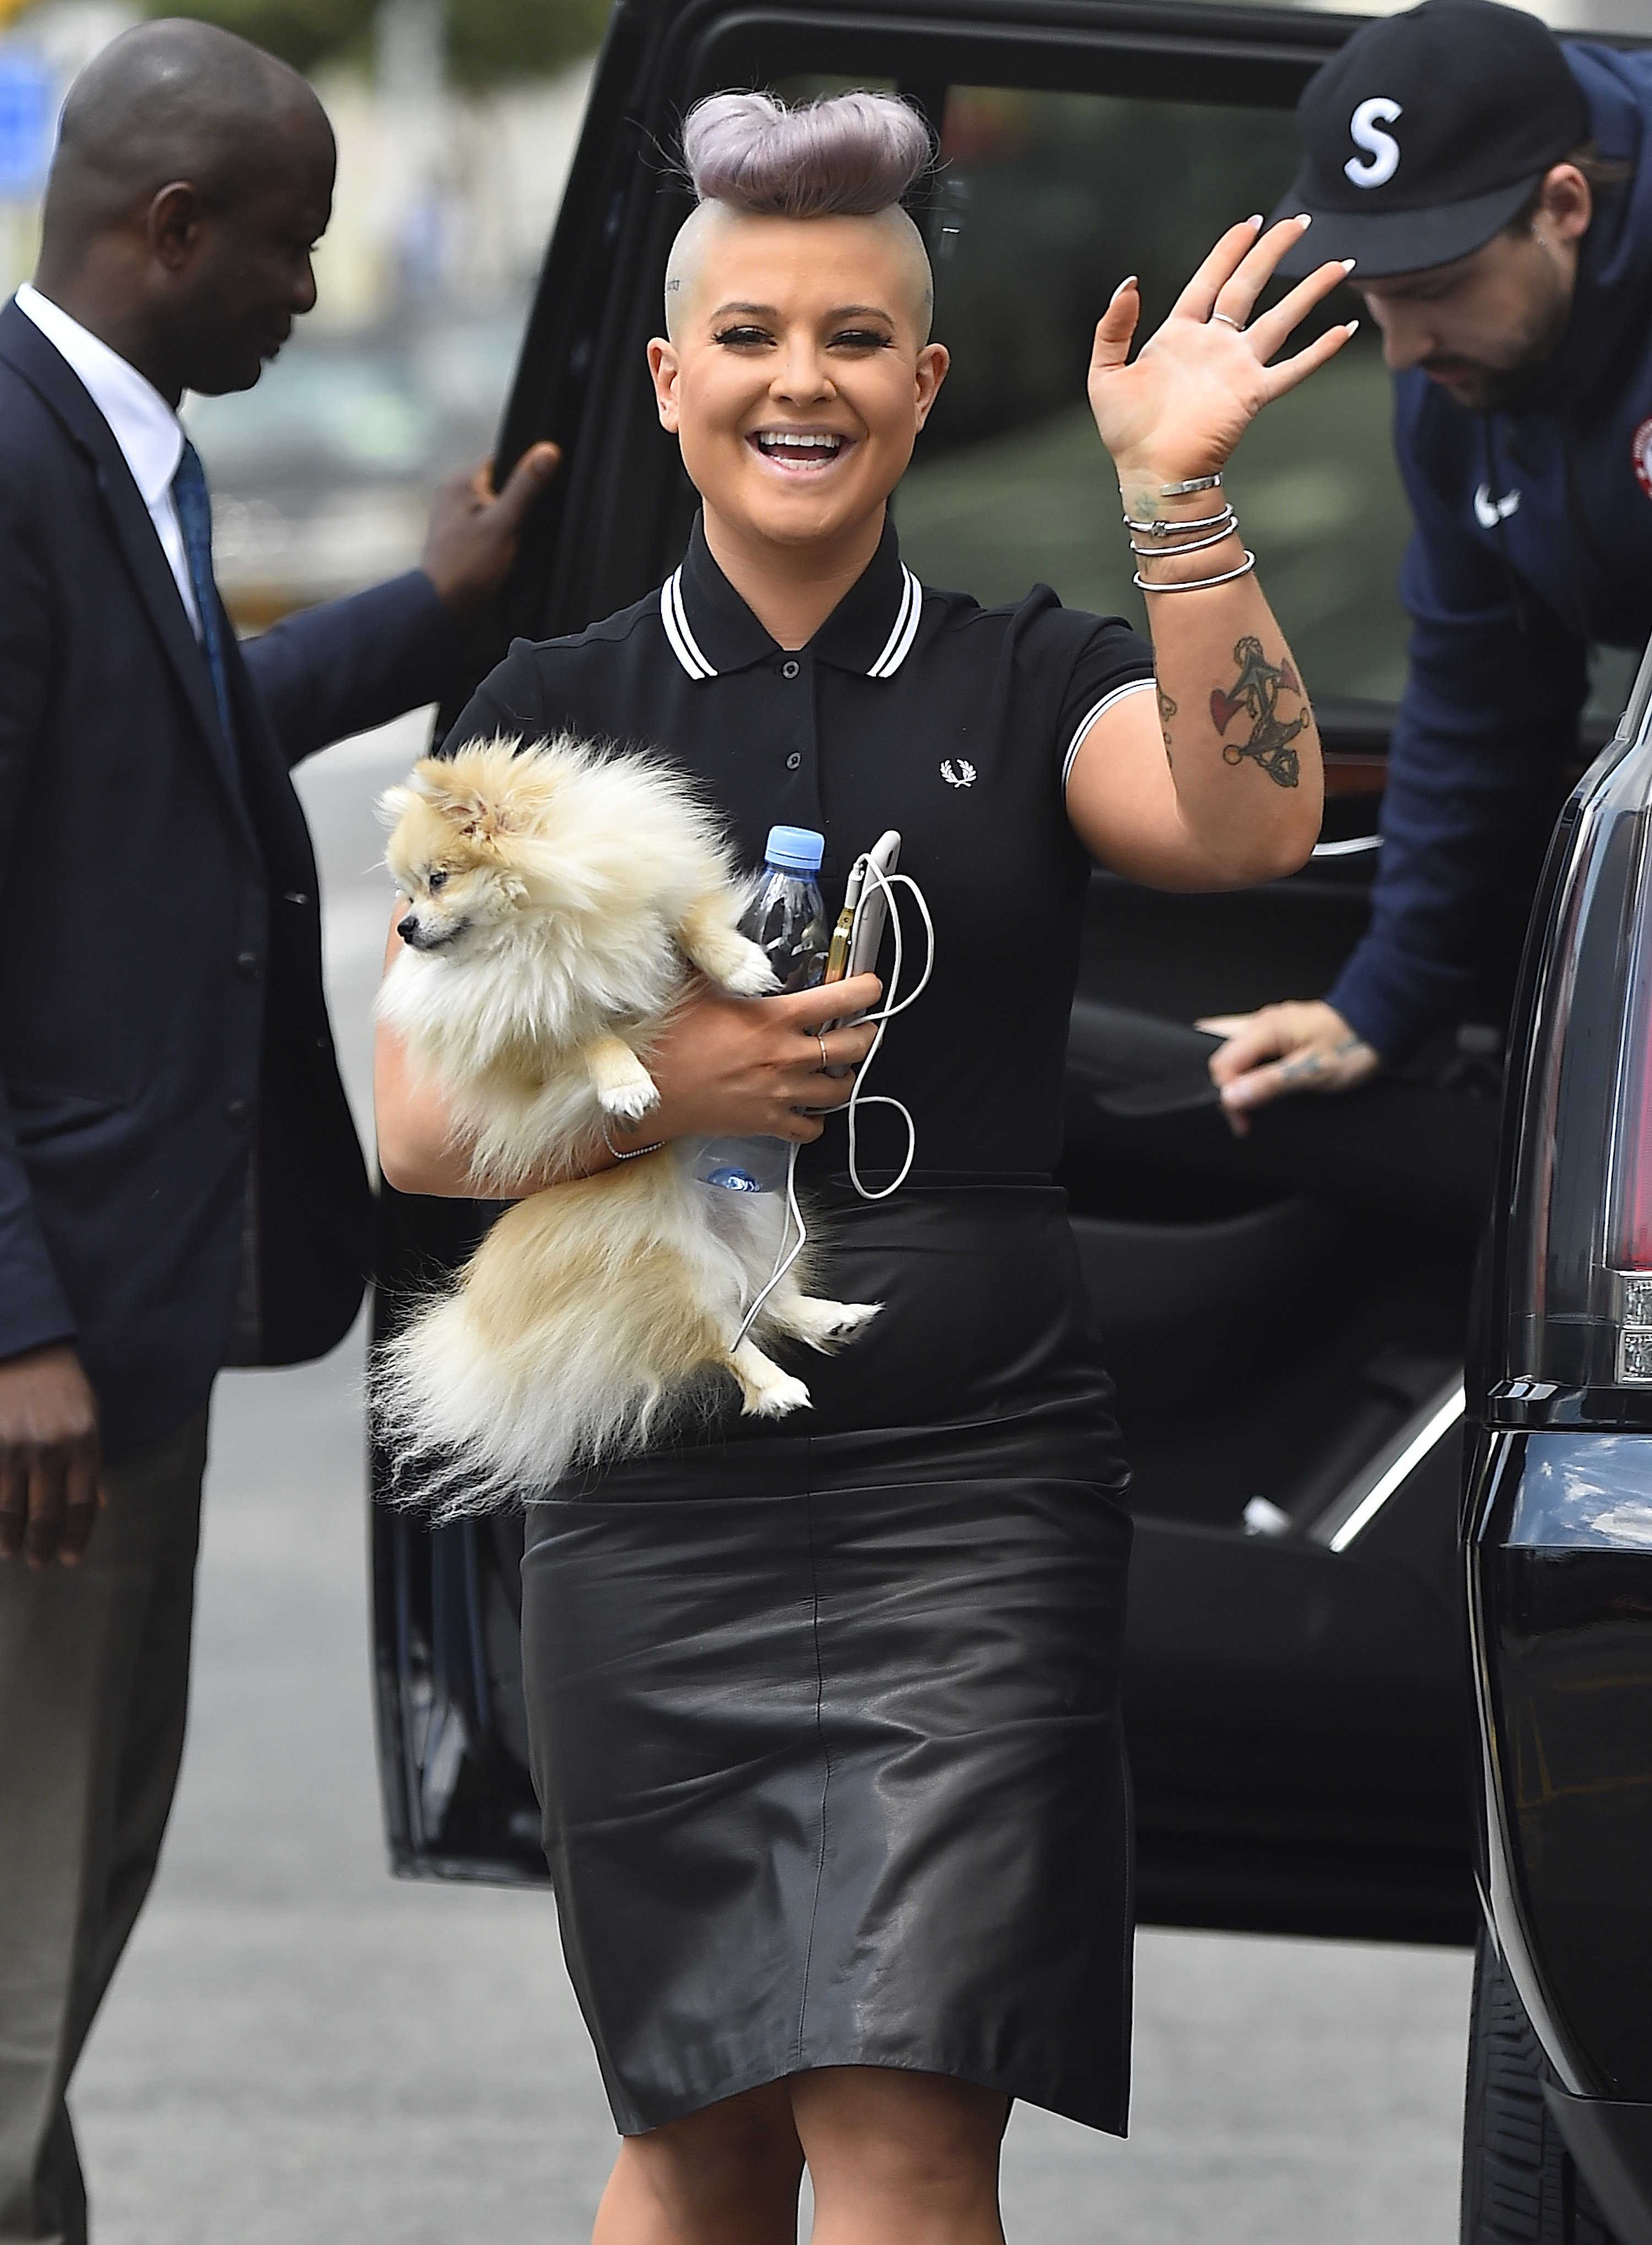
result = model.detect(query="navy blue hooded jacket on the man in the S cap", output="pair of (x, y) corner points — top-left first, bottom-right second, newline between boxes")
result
(1331, 42), (1652, 1060)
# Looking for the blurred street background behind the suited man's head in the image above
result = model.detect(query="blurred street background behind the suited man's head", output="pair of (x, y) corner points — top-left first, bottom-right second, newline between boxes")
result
(0, 0), (606, 628)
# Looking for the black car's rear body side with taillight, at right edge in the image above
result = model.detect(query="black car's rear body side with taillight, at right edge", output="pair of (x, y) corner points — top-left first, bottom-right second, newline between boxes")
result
(1464, 655), (1652, 2245)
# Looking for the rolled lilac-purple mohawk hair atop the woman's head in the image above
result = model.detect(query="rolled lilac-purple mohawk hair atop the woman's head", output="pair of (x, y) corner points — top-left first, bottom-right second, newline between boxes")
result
(682, 94), (932, 218)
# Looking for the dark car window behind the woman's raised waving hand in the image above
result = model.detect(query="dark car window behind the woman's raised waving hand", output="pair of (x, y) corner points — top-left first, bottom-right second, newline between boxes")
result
(898, 85), (1408, 701)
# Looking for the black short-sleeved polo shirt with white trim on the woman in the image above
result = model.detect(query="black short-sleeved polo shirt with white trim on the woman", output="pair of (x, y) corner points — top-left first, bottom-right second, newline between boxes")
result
(447, 507), (1154, 1181)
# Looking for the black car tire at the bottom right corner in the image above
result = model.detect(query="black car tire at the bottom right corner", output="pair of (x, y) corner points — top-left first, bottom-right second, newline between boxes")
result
(1461, 1926), (1616, 2245)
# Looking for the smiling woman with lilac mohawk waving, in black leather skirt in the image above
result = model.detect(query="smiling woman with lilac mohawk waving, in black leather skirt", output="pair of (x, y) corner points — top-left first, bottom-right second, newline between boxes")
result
(379, 79), (1347, 2245)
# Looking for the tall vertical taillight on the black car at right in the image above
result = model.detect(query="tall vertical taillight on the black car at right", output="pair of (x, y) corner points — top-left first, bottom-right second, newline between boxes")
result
(1508, 651), (1652, 1392)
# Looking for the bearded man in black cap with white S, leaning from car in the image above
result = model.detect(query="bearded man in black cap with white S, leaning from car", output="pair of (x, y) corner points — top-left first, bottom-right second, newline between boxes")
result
(1201, 0), (1652, 1129)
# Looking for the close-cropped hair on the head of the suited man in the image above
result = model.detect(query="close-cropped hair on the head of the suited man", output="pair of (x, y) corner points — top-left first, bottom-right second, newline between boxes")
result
(40, 16), (330, 267)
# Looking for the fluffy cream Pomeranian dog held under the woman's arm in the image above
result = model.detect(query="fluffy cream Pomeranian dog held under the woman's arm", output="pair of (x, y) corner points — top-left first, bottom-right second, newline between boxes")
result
(373, 739), (878, 1515)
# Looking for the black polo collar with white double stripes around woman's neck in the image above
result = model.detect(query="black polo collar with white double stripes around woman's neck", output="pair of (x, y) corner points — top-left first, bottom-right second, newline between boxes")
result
(660, 516), (922, 680)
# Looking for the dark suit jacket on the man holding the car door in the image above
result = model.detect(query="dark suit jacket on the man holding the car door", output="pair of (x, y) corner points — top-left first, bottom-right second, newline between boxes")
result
(0, 303), (460, 1455)
